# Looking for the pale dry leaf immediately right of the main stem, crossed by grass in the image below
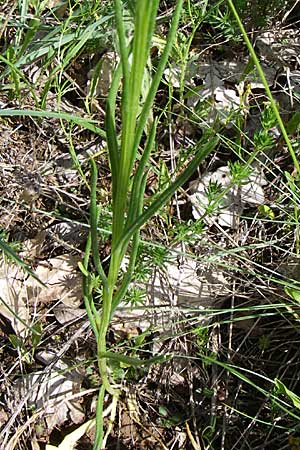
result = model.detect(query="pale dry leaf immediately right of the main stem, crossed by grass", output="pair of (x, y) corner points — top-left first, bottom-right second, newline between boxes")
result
(115, 251), (228, 331)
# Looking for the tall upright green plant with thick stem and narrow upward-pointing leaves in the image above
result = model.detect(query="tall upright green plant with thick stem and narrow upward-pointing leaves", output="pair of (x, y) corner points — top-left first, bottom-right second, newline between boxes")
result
(81, 0), (217, 450)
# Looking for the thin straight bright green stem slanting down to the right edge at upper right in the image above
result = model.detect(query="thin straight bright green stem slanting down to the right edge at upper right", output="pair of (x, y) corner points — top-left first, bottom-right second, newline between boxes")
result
(227, 0), (300, 174)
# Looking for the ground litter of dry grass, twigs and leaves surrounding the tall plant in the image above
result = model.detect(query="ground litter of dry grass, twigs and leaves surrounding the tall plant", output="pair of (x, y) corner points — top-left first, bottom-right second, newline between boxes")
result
(0, 2), (300, 450)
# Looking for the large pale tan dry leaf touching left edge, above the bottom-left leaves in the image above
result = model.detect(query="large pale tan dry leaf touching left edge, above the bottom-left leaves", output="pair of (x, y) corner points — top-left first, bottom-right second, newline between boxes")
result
(0, 253), (82, 337)
